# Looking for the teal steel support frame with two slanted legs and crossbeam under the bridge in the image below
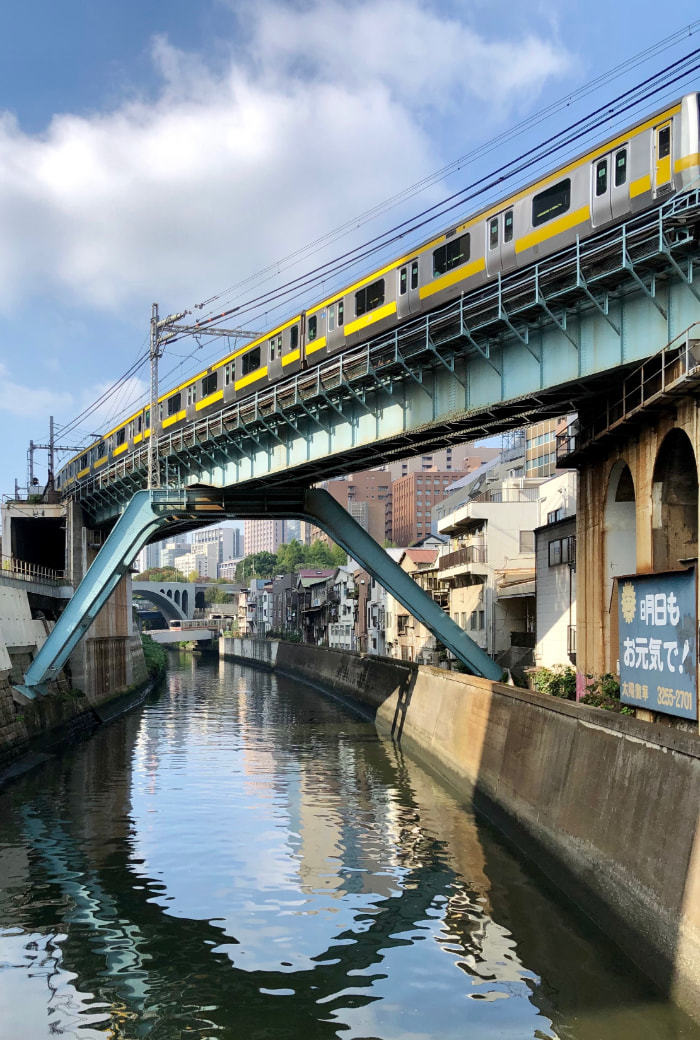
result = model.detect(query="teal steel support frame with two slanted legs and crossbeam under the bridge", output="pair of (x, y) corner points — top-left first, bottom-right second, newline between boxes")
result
(17, 487), (501, 698)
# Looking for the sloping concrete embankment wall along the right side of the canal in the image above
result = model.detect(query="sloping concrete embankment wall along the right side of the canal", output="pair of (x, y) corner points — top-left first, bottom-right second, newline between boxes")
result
(219, 638), (700, 1019)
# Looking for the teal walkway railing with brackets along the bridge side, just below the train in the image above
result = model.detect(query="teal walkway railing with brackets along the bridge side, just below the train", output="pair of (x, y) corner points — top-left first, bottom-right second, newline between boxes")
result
(68, 188), (700, 520)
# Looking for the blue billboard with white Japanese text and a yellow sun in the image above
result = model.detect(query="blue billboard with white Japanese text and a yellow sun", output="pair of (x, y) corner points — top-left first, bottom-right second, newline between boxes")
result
(618, 568), (698, 719)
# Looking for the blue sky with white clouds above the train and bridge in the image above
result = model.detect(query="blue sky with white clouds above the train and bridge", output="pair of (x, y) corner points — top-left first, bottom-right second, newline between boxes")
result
(0, 0), (700, 492)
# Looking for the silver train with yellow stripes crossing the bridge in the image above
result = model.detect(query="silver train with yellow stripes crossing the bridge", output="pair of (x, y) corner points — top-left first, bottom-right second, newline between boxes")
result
(57, 93), (700, 491)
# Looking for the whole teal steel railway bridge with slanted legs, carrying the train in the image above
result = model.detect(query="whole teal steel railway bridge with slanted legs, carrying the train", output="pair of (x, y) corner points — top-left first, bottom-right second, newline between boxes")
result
(15, 185), (700, 696)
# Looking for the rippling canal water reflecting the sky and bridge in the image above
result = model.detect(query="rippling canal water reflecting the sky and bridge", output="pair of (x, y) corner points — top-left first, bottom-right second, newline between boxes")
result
(0, 655), (700, 1040)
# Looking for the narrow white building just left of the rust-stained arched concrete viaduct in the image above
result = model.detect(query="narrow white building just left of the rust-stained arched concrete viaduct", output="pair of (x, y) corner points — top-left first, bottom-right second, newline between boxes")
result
(535, 470), (576, 668)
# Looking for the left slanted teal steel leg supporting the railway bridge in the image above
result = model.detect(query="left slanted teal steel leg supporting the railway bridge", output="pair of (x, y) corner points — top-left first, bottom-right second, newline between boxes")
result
(17, 491), (173, 698)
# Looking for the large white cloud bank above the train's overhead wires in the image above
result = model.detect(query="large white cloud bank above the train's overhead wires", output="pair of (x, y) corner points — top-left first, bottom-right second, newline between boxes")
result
(0, 0), (568, 312)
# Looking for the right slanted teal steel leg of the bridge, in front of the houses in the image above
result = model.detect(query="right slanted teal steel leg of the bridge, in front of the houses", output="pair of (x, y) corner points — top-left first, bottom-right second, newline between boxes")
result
(297, 488), (502, 680)
